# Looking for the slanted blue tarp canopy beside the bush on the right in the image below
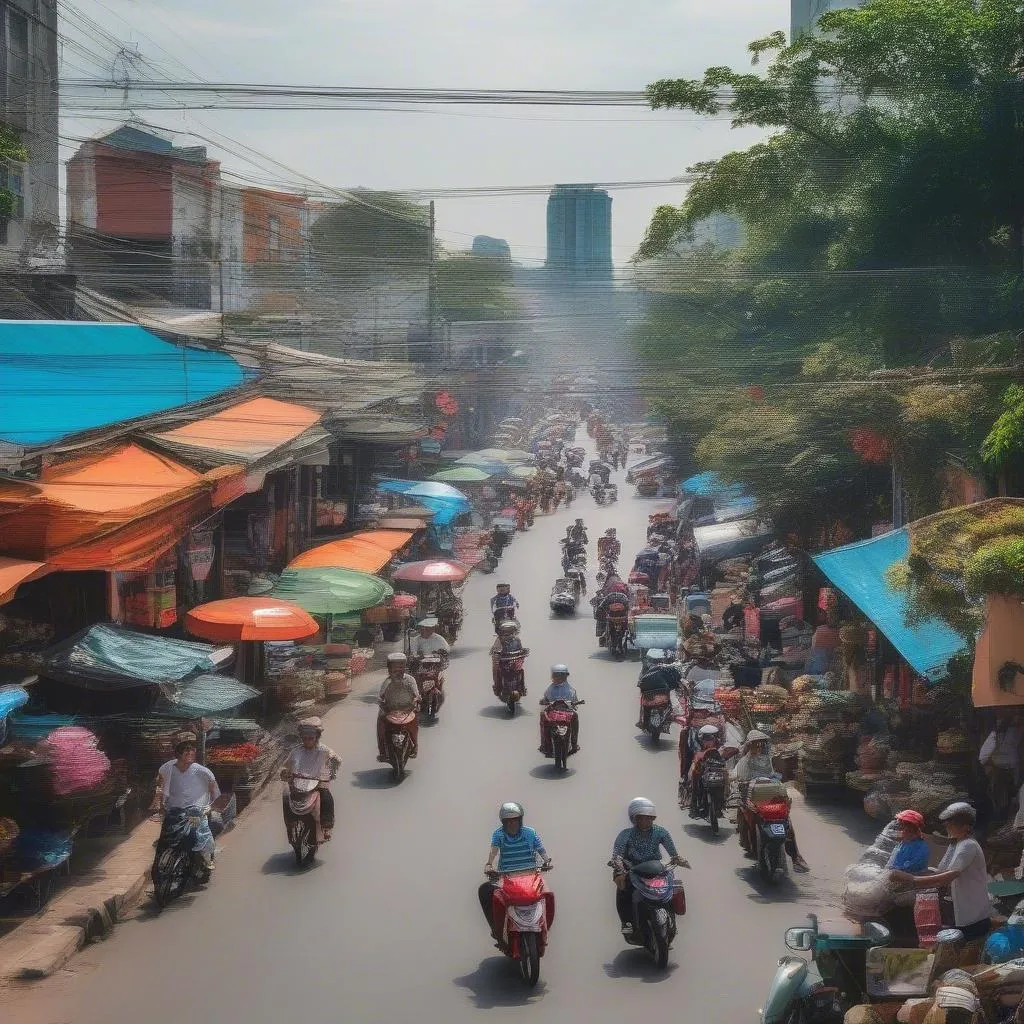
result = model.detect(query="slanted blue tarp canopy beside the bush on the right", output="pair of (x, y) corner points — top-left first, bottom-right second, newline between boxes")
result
(814, 527), (966, 680)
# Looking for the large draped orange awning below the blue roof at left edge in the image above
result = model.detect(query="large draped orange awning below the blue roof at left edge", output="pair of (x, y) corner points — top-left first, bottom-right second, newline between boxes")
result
(0, 443), (243, 570)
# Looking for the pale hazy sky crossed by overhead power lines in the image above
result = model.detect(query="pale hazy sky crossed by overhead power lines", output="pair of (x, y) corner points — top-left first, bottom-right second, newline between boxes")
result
(61, 0), (790, 264)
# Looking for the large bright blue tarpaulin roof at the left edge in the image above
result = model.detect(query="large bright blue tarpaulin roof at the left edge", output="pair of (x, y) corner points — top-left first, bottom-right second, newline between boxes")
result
(0, 321), (245, 445)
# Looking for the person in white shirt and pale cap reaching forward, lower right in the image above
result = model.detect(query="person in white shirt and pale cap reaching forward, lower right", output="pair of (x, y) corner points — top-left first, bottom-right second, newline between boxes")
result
(893, 801), (992, 942)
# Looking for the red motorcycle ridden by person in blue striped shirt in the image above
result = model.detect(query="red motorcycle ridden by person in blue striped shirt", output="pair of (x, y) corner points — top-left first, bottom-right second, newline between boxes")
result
(487, 867), (555, 988)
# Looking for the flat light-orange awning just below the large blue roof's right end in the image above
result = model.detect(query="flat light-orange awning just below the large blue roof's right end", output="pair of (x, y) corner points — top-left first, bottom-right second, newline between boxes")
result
(148, 398), (329, 463)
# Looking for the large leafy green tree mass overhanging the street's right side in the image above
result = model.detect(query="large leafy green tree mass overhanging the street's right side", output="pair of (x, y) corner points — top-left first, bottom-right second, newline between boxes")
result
(637, 0), (1024, 544)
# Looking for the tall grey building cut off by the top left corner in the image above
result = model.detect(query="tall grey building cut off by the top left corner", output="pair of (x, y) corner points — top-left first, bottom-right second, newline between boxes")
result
(0, 0), (60, 268)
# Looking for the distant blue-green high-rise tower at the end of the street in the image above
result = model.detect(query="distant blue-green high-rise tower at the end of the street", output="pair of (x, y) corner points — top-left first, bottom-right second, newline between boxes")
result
(547, 185), (611, 276)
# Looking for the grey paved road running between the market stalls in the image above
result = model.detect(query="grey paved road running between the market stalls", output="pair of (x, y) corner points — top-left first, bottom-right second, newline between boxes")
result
(4, 434), (871, 1024)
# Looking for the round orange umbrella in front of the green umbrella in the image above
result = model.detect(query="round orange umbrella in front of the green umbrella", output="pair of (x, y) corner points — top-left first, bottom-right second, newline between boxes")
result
(184, 597), (319, 688)
